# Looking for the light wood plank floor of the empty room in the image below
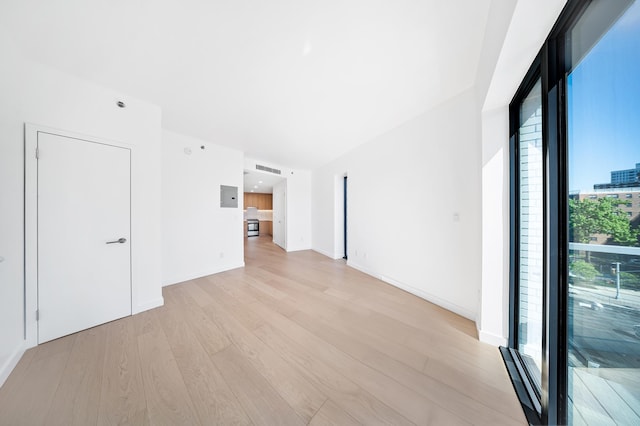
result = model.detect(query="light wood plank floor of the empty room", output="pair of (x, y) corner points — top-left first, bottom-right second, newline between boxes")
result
(0, 238), (526, 425)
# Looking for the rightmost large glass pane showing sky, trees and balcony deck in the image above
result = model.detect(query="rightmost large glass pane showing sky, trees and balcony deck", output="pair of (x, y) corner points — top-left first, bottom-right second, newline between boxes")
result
(566, 1), (640, 425)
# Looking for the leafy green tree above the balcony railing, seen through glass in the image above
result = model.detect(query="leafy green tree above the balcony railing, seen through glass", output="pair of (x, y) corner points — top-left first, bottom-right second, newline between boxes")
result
(569, 198), (638, 246)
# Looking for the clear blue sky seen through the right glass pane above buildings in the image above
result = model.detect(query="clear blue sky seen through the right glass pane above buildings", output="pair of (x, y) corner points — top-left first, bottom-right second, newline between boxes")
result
(568, 1), (640, 191)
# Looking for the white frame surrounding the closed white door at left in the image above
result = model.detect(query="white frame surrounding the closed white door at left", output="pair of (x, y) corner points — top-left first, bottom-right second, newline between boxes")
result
(24, 123), (134, 348)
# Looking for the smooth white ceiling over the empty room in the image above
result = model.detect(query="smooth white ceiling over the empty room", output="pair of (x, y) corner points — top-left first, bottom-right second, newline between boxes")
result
(0, 0), (491, 168)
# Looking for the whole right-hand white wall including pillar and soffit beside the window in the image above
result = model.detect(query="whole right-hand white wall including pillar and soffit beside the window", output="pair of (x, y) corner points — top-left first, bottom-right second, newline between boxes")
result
(312, 0), (565, 345)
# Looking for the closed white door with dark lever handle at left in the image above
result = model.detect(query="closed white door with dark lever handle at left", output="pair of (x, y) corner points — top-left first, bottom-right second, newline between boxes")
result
(38, 132), (131, 343)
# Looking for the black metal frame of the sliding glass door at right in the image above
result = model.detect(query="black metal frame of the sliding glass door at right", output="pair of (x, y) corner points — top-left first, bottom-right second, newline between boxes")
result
(501, 0), (591, 424)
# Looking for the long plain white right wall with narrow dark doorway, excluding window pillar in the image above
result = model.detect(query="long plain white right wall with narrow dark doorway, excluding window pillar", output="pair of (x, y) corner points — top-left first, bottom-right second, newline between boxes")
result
(312, 90), (481, 319)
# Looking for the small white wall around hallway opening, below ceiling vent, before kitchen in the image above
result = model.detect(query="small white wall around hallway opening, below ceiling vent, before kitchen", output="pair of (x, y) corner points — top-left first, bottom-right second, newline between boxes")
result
(244, 158), (311, 251)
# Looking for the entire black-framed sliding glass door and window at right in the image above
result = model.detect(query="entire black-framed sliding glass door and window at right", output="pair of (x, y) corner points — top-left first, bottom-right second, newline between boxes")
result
(503, 0), (640, 425)
